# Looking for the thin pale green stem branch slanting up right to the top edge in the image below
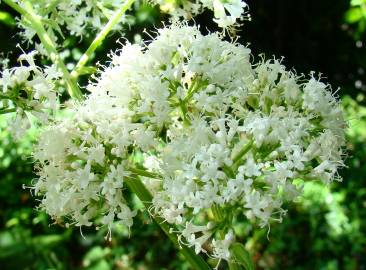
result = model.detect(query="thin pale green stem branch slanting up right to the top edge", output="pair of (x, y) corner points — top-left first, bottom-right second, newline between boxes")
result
(71, 0), (135, 78)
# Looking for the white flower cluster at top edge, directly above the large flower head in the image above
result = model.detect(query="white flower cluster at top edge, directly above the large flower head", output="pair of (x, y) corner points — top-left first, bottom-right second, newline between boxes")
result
(151, 0), (247, 28)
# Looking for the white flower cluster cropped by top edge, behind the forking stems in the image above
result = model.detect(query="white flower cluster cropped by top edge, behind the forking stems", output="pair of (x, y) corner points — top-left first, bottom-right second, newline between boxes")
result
(16, 0), (129, 40)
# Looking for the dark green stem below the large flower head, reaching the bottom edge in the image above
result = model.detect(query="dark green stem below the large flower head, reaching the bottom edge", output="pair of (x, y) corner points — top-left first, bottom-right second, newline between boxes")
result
(125, 177), (211, 270)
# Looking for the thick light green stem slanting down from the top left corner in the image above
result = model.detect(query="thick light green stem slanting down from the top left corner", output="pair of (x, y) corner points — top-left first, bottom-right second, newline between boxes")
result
(3, 0), (83, 100)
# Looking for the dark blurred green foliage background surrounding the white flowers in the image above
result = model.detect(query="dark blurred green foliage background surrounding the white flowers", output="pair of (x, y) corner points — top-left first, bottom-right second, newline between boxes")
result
(0, 0), (366, 270)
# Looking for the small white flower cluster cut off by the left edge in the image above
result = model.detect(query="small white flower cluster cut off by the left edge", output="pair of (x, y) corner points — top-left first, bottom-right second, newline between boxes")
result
(0, 51), (61, 138)
